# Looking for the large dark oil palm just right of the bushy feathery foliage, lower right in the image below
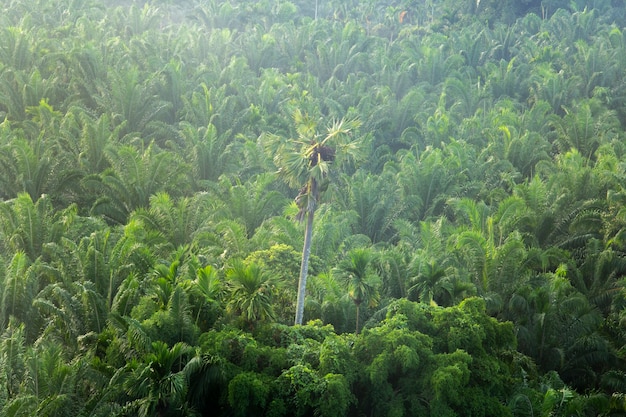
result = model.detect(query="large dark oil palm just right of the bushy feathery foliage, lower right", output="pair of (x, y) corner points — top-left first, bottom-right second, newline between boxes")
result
(508, 267), (615, 387)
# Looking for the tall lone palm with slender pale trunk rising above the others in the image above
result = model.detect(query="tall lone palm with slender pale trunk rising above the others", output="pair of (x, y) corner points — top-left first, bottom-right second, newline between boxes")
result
(261, 110), (360, 325)
